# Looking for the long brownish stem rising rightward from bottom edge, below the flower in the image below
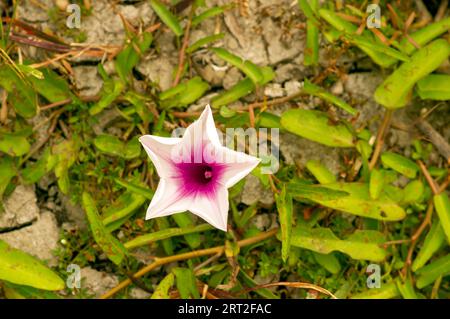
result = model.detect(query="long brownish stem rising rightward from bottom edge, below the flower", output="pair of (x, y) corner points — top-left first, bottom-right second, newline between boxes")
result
(100, 228), (278, 299)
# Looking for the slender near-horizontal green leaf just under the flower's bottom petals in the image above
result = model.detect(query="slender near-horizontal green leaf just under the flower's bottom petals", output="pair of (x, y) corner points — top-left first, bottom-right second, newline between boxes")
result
(124, 224), (213, 249)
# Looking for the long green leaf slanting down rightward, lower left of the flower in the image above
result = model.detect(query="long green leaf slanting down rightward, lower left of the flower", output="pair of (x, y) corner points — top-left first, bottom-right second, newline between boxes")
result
(82, 192), (127, 265)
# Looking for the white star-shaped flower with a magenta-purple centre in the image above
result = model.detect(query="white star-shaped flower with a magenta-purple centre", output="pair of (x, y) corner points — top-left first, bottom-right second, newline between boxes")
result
(139, 105), (260, 231)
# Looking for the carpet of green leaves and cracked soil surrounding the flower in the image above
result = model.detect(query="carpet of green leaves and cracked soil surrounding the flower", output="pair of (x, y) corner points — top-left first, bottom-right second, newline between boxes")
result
(0, 0), (450, 299)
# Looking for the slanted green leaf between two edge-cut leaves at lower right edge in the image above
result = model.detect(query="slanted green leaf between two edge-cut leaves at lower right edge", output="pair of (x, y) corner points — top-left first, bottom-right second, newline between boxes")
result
(411, 221), (445, 272)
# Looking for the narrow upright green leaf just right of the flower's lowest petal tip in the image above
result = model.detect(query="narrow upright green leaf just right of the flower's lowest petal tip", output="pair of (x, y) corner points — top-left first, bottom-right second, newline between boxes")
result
(275, 185), (293, 262)
